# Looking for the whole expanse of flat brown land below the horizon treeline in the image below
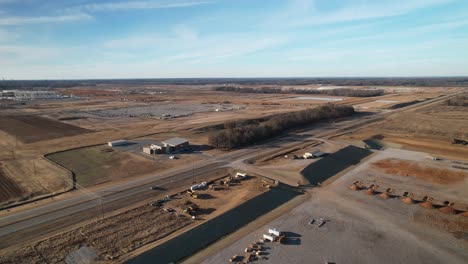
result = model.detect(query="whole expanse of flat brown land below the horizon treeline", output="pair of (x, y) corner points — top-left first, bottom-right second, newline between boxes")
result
(0, 83), (468, 264)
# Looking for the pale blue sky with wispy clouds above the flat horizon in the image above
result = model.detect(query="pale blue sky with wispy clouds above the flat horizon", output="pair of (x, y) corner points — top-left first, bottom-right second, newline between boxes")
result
(0, 0), (468, 79)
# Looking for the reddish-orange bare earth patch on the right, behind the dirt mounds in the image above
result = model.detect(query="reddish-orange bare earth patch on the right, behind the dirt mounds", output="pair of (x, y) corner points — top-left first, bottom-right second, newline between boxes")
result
(372, 159), (468, 184)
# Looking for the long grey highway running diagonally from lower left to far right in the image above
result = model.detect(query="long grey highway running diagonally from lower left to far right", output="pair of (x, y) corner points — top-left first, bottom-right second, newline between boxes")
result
(0, 91), (456, 248)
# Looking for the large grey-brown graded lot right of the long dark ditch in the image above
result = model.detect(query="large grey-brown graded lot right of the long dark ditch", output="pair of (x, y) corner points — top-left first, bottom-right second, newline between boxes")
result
(200, 149), (468, 264)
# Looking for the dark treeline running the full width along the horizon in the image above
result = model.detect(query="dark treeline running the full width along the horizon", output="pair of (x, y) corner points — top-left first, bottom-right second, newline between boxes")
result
(0, 77), (468, 89)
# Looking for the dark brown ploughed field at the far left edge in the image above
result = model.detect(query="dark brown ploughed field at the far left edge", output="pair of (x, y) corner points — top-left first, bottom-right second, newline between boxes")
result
(0, 115), (91, 143)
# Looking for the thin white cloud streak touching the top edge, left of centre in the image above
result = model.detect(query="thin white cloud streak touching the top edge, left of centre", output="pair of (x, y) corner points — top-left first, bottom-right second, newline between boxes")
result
(74, 1), (213, 11)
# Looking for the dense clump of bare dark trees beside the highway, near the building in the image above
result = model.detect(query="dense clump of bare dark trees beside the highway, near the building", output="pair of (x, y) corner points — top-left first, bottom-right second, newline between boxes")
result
(209, 104), (354, 149)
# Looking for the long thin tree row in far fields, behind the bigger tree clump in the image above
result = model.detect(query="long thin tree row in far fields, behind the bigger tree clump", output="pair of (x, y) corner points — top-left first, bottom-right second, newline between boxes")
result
(213, 86), (384, 97)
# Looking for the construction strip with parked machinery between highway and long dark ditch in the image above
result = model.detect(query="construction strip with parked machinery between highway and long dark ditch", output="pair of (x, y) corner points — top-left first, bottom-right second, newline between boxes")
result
(1, 171), (277, 263)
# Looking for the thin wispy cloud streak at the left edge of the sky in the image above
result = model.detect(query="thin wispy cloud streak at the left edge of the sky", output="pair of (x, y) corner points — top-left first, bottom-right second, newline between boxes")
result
(0, 13), (93, 26)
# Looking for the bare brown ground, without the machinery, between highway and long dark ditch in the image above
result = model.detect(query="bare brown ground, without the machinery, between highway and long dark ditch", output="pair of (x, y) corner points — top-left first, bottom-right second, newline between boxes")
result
(0, 174), (266, 263)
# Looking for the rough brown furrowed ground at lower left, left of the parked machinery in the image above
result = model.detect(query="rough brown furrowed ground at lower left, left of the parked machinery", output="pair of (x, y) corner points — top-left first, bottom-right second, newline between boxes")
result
(0, 206), (192, 263)
